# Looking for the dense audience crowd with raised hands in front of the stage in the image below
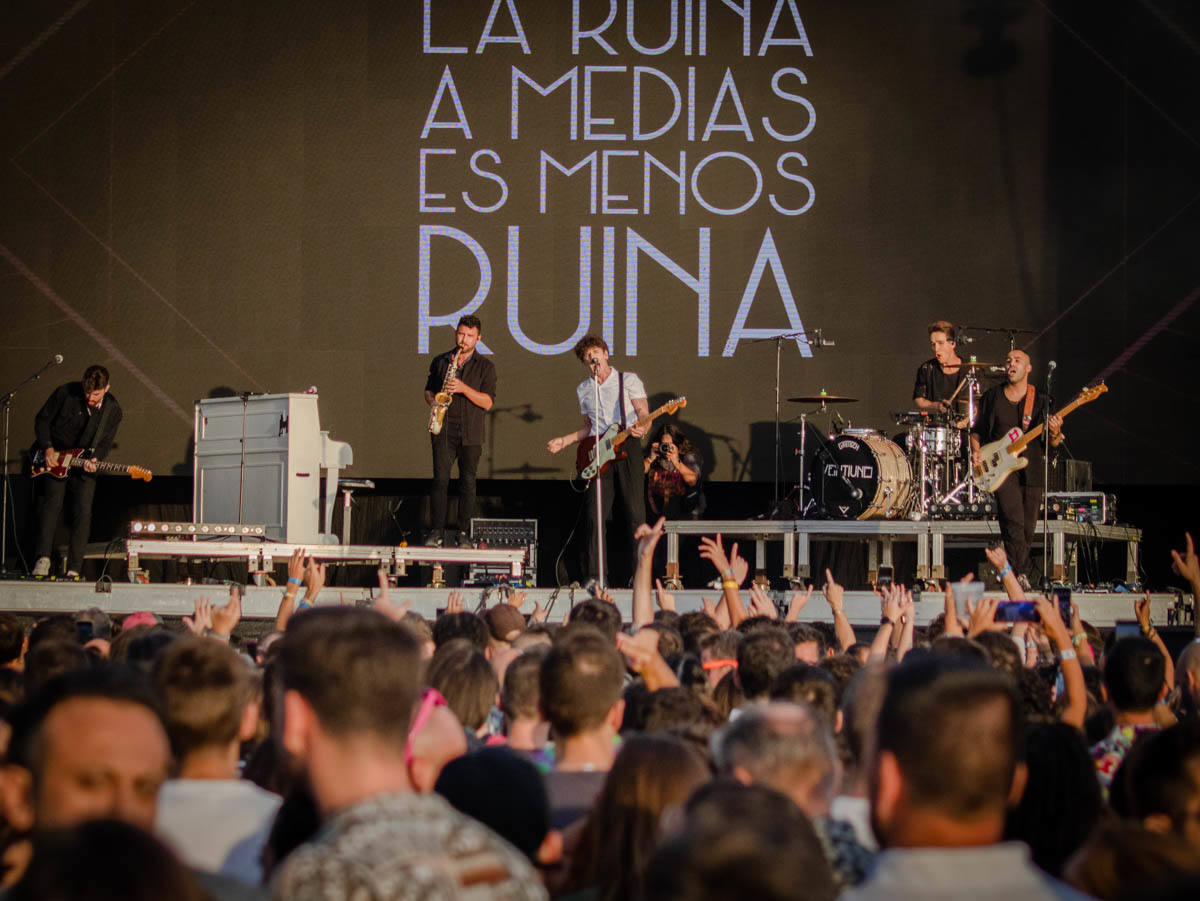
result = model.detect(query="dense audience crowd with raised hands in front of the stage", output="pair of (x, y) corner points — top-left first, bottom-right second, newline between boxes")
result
(0, 519), (1200, 901)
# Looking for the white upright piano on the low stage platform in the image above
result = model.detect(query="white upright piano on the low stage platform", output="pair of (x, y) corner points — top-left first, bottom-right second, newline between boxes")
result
(192, 394), (354, 545)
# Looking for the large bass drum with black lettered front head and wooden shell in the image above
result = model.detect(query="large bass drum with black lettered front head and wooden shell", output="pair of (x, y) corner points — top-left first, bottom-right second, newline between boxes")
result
(817, 434), (913, 519)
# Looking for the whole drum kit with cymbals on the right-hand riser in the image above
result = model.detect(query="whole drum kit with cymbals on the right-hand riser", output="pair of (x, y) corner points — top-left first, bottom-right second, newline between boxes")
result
(787, 360), (1003, 521)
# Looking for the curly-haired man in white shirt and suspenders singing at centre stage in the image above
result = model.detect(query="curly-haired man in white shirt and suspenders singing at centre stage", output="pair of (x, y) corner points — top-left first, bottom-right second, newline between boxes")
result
(546, 335), (650, 584)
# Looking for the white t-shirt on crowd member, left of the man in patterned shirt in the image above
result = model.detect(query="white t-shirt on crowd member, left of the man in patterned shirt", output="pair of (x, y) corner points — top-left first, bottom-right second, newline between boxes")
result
(154, 779), (282, 885)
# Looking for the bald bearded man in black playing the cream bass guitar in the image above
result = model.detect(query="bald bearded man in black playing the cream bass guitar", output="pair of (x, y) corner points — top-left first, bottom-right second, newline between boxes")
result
(971, 350), (1063, 588)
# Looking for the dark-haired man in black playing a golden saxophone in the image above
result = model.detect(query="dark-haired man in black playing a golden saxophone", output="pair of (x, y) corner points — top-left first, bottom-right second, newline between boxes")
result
(425, 316), (496, 546)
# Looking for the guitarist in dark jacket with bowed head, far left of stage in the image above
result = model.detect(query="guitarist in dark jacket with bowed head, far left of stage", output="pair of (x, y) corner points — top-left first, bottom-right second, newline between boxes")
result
(30, 358), (121, 578)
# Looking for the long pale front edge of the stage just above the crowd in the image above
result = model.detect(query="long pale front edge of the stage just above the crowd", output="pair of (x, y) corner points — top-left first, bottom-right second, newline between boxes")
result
(0, 581), (1192, 626)
